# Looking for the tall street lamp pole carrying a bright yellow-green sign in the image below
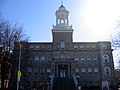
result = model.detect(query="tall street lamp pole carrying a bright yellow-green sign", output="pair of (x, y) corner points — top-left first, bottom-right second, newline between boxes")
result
(14, 35), (22, 90)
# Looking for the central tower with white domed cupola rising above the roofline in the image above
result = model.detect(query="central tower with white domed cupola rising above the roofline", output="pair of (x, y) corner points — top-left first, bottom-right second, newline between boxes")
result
(52, 4), (73, 49)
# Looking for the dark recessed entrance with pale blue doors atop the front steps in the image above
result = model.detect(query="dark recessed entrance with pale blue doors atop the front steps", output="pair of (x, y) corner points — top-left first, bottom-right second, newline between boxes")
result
(58, 65), (68, 78)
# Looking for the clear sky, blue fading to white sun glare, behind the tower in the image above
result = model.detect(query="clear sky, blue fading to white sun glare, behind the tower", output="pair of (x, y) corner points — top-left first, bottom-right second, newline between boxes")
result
(0, 0), (120, 67)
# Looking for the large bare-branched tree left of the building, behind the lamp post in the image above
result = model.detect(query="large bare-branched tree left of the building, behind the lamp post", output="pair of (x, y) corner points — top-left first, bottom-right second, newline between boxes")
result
(0, 19), (29, 88)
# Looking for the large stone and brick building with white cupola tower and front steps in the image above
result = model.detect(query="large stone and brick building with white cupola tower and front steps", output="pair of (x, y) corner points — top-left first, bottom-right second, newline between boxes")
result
(12, 5), (115, 90)
